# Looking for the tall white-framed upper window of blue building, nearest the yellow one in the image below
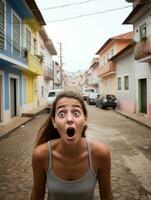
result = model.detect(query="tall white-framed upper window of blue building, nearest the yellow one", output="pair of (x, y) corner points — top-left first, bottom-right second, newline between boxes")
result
(13, 14), (21, 56)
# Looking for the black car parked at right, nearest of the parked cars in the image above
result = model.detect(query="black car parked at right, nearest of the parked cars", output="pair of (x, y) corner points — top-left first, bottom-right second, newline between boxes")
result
(96, 94), (117, 109)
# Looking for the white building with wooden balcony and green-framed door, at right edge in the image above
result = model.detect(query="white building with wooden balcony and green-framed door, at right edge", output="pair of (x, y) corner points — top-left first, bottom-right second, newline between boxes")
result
(123, 0), (151, 119)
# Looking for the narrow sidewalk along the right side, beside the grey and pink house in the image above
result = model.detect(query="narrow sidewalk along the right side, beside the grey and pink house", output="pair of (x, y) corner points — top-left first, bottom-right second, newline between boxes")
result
(115, 110), (151, 128)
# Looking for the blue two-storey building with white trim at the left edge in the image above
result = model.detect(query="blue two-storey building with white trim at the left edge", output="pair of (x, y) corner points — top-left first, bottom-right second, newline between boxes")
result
(0, 0), (33, 122)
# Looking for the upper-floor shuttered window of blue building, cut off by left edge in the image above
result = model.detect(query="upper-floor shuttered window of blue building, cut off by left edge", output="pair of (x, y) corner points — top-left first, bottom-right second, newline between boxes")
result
(0, 0), (5, 49)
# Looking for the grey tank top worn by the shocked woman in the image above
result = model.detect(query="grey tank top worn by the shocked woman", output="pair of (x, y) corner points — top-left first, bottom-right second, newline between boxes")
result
(46, 139), (97, 200)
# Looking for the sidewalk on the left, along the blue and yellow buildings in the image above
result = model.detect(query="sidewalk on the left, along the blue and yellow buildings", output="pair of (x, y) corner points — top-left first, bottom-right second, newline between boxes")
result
(0, 106), (45, 140)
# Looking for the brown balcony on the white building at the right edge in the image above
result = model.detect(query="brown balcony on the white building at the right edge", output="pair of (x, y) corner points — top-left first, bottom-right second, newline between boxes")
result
(135, 36), (151, 62)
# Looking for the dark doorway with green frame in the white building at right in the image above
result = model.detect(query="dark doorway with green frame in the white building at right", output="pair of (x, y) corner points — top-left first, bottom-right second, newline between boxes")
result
(140, 79), (147, 113)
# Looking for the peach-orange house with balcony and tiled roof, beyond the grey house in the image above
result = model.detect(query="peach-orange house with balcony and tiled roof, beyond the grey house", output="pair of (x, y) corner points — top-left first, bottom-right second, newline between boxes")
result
(96, 32), (132, 95)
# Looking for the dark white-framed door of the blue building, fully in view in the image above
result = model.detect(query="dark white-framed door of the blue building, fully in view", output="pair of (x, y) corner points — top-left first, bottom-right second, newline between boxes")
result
(10, 78), (17, 117)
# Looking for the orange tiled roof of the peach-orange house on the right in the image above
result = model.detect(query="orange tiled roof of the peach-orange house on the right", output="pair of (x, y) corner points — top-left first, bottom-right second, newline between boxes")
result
(96, 32), (133, 54)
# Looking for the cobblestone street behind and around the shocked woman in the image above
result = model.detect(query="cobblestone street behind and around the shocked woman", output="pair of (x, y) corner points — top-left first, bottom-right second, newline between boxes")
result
(0, 103), (151, 200)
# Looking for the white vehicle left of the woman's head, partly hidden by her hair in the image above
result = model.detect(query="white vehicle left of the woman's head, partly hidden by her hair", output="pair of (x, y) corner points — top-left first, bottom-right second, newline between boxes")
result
(47, 89), (63, 112)
